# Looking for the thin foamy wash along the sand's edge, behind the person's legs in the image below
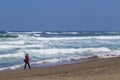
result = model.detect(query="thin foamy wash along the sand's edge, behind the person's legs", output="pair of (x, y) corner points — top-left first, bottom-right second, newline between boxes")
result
(0, 56), (100, 72)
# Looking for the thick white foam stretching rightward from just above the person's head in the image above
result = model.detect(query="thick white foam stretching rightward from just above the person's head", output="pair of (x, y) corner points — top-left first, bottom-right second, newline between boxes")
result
(25, 47), (111, 55)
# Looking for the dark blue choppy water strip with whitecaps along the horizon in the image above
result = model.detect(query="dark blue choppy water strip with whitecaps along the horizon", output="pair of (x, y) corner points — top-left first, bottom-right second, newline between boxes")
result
(0, 31), (120, 38)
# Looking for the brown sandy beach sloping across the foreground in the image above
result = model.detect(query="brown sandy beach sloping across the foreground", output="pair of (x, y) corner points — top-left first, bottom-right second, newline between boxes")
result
(0, 57), (120, 80)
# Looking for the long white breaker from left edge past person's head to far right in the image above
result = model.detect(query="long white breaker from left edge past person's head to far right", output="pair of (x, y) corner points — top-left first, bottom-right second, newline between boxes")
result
(0, 47), (111, 58)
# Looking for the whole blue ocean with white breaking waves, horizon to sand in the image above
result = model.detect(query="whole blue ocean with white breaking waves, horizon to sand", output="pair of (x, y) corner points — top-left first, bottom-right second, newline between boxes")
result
(0, 31), (120, 71)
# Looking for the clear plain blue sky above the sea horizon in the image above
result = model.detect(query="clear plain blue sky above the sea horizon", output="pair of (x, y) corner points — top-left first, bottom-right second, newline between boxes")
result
(0, 0), (120, 31)
